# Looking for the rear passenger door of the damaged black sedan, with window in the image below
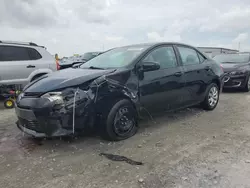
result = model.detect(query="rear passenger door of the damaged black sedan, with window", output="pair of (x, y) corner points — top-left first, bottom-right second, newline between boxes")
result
(175, 45), (209, 105)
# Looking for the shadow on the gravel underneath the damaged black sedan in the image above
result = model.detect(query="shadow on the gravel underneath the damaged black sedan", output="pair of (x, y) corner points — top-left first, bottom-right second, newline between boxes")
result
(16, 107), (204, 153)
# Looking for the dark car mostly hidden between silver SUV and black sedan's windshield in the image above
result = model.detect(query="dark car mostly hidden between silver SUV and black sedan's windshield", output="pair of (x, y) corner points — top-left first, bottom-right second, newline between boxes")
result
(59, 52), (102, 69)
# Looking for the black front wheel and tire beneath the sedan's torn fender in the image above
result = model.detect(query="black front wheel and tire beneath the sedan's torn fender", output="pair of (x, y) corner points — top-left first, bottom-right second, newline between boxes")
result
(100, 99), (138, 141)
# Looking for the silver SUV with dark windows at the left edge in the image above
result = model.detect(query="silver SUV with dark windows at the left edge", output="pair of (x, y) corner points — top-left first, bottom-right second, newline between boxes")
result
(0, 41), (59, 85)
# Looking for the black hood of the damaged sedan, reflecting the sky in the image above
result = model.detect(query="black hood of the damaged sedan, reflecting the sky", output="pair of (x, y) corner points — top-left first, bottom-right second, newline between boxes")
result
(24, 68), (115, 93)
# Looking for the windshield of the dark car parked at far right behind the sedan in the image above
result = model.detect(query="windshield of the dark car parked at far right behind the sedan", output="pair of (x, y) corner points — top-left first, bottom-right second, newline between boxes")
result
(214, 54), (250, 63)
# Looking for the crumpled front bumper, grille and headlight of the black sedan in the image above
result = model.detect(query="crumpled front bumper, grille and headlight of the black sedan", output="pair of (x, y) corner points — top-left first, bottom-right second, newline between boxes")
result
(16, 88), (94, 137)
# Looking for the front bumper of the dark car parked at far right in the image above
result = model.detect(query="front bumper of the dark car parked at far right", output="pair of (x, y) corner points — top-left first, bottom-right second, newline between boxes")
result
(223, 75), (248, 89)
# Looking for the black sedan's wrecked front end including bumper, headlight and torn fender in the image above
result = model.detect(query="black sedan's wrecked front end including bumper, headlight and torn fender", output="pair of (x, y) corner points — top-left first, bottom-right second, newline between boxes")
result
(16, 76), (138, 137)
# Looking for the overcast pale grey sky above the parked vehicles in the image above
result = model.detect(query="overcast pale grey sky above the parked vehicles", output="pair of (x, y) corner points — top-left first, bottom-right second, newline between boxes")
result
(0, 0), (250, 57)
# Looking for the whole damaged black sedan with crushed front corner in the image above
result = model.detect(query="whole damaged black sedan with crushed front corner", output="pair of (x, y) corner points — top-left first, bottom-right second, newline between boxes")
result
(16, 43), (223, 140)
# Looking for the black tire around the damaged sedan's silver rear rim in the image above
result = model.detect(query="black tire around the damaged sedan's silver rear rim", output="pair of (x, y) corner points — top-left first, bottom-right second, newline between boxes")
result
(201, 83), (220, 111)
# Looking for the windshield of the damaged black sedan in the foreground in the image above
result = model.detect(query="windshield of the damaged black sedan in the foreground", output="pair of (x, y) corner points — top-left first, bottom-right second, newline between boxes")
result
(81, 46), (146, 69)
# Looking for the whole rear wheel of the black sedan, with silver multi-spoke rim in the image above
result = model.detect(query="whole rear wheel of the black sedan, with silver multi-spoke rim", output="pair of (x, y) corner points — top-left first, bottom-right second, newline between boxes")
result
(202, 83), (219, 110)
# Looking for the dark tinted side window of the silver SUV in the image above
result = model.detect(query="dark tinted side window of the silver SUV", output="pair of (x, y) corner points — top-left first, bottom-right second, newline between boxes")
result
(0, 46), (42, 61)
